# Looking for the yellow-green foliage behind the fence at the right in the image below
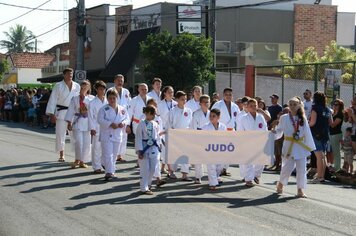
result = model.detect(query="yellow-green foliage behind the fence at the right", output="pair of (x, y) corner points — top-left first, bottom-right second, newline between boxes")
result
(279, 41), (356, 83)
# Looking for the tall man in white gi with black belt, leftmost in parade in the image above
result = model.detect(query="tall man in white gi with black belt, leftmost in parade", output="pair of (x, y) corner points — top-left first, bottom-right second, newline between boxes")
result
(46, 68), (80, 162)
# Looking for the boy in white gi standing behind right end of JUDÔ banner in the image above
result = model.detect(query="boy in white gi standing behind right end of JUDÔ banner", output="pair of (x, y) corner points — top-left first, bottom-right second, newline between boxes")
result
(237, 98), (268, 187)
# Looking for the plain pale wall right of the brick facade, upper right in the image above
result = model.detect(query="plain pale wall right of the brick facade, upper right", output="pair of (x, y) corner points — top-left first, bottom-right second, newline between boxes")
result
(336, 12), (355, 46)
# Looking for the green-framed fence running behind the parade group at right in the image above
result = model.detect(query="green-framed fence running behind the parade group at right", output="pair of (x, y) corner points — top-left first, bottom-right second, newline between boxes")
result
(216, 61), (356, 105)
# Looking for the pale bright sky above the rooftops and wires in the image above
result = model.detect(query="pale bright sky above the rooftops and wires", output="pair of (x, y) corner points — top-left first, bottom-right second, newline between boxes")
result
(0, 0), (356, 53)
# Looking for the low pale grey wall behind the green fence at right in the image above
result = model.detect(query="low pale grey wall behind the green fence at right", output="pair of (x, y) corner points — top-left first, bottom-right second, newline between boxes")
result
(215, 72), (352, 106)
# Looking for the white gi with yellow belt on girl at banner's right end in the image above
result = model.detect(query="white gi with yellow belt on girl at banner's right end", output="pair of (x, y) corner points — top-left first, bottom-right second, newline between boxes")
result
(275, 114), (315, 189)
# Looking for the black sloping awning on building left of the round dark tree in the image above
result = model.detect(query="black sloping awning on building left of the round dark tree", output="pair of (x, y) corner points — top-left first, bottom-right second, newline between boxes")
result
(100, 27), (160, 82)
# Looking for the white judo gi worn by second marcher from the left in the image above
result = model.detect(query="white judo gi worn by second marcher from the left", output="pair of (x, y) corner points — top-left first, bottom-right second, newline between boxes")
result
(65, 95), (94, 162)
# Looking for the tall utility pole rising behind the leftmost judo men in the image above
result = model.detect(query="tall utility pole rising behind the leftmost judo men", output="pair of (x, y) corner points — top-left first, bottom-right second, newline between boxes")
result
(75, 0), (85, 70)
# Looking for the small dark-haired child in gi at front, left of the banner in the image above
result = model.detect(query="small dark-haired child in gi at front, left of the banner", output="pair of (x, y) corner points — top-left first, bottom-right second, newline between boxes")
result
(135, 106), (161, 195)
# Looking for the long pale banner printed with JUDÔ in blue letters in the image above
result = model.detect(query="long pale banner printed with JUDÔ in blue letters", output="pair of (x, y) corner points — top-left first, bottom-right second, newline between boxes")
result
(165, 129), (274, 165)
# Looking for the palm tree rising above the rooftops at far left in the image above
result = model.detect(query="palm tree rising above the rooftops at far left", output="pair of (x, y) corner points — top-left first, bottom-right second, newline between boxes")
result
(0, 24), (35, 52)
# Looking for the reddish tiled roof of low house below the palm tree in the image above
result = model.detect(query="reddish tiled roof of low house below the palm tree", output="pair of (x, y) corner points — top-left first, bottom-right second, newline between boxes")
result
(8, 52), (55, 69)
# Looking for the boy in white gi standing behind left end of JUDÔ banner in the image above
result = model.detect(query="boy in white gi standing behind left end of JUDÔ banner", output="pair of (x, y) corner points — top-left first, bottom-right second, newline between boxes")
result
(168, 91), (193, 181)
